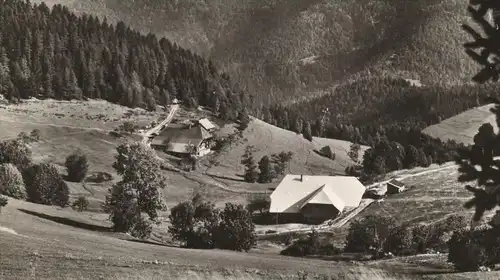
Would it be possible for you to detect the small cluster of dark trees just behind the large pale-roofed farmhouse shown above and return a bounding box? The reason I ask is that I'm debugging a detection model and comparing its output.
[241,145,293,183]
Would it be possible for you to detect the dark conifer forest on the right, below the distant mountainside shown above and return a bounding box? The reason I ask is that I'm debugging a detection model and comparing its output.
[261,78,500,176]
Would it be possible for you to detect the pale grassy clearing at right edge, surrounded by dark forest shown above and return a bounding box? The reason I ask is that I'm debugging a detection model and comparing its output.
[423,104,498,145]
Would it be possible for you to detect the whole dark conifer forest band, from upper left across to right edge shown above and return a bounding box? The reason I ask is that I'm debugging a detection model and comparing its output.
[0,0,484,178]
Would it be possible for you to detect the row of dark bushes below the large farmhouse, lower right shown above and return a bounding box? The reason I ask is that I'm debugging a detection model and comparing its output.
[282,215,467,258]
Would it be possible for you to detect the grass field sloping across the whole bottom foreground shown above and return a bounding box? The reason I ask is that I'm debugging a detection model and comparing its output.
[0,199,499,280]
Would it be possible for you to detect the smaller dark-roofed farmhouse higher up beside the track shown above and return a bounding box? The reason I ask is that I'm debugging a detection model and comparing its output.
[151,124,213,157]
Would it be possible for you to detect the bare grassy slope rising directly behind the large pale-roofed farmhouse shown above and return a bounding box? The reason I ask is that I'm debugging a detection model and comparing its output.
[207,119,368,184]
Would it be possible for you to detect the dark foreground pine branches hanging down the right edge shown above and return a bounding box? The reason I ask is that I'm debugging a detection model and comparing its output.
[456,0,500,226]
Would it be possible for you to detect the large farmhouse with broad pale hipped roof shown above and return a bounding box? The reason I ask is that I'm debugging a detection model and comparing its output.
[269,174,365,223]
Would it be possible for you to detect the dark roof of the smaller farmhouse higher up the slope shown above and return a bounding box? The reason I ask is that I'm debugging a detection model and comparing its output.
[151,124,212,152]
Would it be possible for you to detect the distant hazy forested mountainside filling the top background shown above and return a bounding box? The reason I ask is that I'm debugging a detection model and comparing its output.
[33,0,477,105]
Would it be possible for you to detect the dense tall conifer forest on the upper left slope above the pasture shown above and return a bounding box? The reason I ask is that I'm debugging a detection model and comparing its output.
[0,0,249,119]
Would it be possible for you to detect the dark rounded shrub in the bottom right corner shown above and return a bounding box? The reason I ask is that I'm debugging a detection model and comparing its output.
[448,227,500,271]
